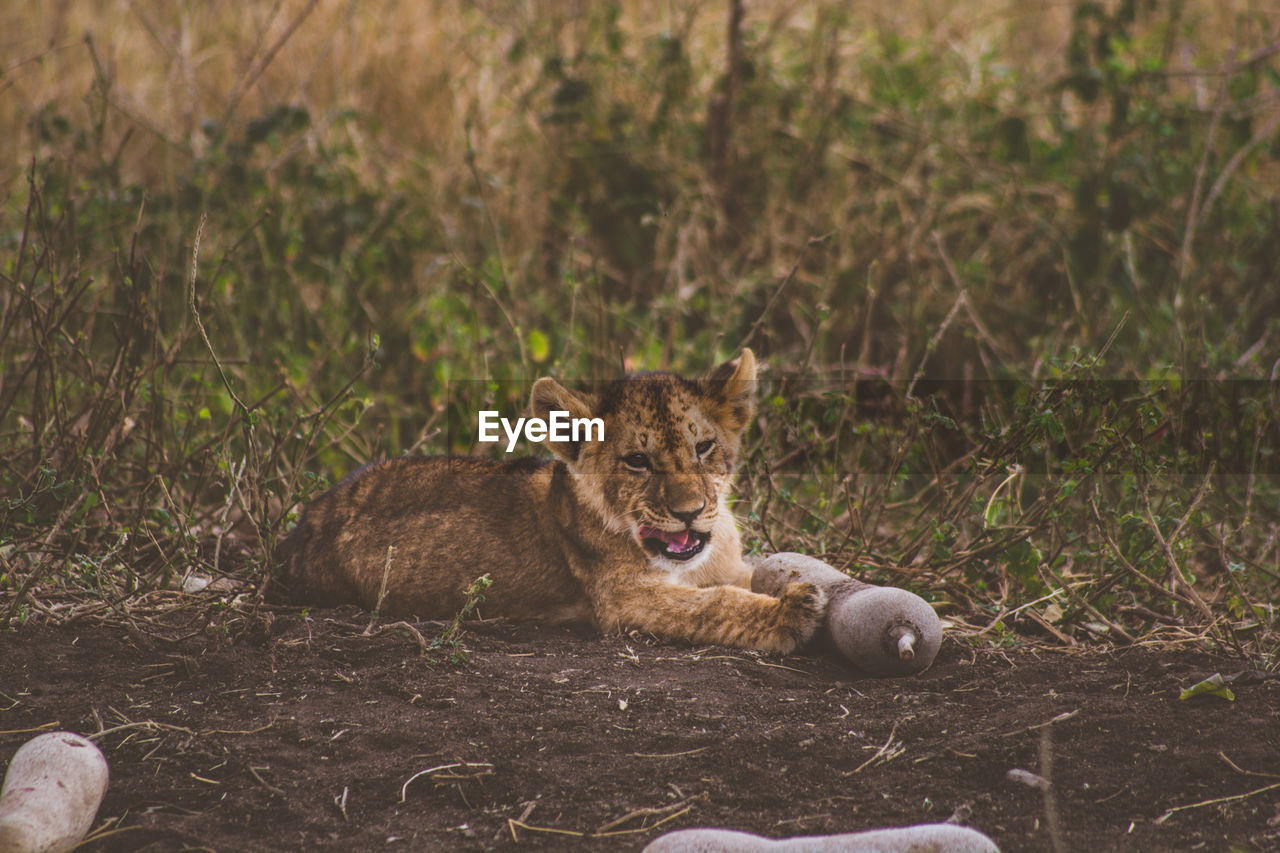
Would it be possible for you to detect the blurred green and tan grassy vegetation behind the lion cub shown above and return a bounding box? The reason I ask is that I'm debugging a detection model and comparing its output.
[0,0,1280,650]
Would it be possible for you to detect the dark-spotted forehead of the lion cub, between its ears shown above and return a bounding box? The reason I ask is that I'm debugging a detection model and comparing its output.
[598,373,716,452]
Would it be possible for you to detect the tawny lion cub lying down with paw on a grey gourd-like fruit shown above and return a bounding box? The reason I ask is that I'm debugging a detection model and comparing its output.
[280,350,826,653]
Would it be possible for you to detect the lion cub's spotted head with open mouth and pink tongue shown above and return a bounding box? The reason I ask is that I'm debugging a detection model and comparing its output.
[531,350,755,570]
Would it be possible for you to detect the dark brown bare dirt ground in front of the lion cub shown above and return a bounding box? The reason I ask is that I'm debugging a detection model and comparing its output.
[0,611,1280,852]
